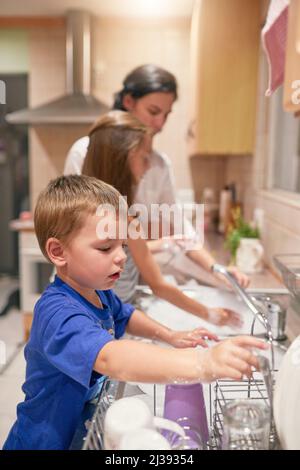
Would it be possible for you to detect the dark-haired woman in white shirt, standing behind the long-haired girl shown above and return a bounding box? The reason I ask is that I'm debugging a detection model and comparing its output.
[64,64,249,287]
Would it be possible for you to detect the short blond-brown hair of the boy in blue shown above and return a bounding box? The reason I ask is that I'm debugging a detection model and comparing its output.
[34,175,121,261]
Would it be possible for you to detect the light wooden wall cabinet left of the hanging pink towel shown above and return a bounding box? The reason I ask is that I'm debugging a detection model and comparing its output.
[190,0,262,156]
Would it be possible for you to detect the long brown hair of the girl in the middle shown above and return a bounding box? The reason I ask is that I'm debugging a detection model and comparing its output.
[82,111,150,205]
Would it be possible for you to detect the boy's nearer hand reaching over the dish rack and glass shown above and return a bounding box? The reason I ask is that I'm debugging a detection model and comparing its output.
[199,336,268,382]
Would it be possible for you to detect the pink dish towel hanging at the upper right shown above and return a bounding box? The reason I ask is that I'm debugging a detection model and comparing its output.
[261,0,289,96]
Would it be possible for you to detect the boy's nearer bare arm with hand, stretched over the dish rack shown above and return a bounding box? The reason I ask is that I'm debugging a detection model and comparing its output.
[94,336,267,383]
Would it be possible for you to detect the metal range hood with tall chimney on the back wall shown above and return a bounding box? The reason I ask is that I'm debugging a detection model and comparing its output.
[6,10,109,125]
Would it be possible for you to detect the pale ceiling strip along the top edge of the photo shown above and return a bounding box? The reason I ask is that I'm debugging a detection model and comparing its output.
[0,0,195,17]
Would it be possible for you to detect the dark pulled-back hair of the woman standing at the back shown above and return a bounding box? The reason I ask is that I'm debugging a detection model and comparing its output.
[113,64,177,111]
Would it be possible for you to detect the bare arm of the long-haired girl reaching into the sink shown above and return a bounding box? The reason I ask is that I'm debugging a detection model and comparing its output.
[128,238,240,326]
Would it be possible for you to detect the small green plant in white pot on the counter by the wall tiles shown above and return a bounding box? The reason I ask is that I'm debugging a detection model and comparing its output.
[225,207,263,273]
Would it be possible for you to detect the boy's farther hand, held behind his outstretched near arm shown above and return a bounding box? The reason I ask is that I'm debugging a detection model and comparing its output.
[168,328,219,348]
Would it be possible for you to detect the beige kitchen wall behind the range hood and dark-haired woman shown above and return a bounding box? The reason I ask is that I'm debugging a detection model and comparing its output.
[29,17,191,205]
